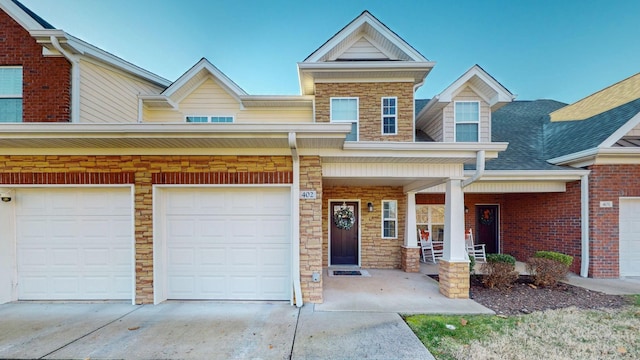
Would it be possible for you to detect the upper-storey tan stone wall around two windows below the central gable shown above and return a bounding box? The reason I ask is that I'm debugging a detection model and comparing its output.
[315,82,414,141]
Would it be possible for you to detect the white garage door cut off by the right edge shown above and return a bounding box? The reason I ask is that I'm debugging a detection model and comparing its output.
[620,198,640,276]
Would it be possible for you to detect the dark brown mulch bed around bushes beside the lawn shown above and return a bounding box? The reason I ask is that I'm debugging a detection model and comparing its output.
[431,275,629,315]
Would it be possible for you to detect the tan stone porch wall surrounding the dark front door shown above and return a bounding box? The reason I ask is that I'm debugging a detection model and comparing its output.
[322,186,407,269]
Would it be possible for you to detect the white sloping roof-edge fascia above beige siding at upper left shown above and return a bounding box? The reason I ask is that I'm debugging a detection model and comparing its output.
[29,29,171,87]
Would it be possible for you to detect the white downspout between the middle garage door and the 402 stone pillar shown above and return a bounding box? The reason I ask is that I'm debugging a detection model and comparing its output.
[289,132,303,307]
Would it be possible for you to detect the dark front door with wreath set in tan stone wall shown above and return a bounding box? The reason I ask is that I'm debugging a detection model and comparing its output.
[329,202,359,265]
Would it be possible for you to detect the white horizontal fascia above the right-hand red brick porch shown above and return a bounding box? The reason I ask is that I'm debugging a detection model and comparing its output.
[476,169,591,182]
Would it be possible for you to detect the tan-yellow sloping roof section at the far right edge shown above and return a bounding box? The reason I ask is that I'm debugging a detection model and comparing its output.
[551,73,640,121]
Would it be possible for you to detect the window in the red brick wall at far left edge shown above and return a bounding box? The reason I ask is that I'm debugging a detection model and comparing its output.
[0,66,22,122]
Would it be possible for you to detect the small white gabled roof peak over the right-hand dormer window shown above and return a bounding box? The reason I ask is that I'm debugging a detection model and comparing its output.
[416,64,515,129]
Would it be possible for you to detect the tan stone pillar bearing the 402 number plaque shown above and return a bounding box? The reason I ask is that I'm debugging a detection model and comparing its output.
[300,156,324,303]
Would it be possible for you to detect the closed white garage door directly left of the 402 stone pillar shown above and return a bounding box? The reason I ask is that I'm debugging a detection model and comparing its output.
[165,188,291,300]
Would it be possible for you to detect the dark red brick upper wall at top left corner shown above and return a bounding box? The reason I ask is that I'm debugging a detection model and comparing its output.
[0,11,71,122]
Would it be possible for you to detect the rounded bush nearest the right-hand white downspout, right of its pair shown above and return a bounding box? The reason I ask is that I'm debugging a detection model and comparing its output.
[527,251,573,286]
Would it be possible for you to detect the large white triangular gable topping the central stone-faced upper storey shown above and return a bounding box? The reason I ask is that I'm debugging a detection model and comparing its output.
[298,11,435,95]
